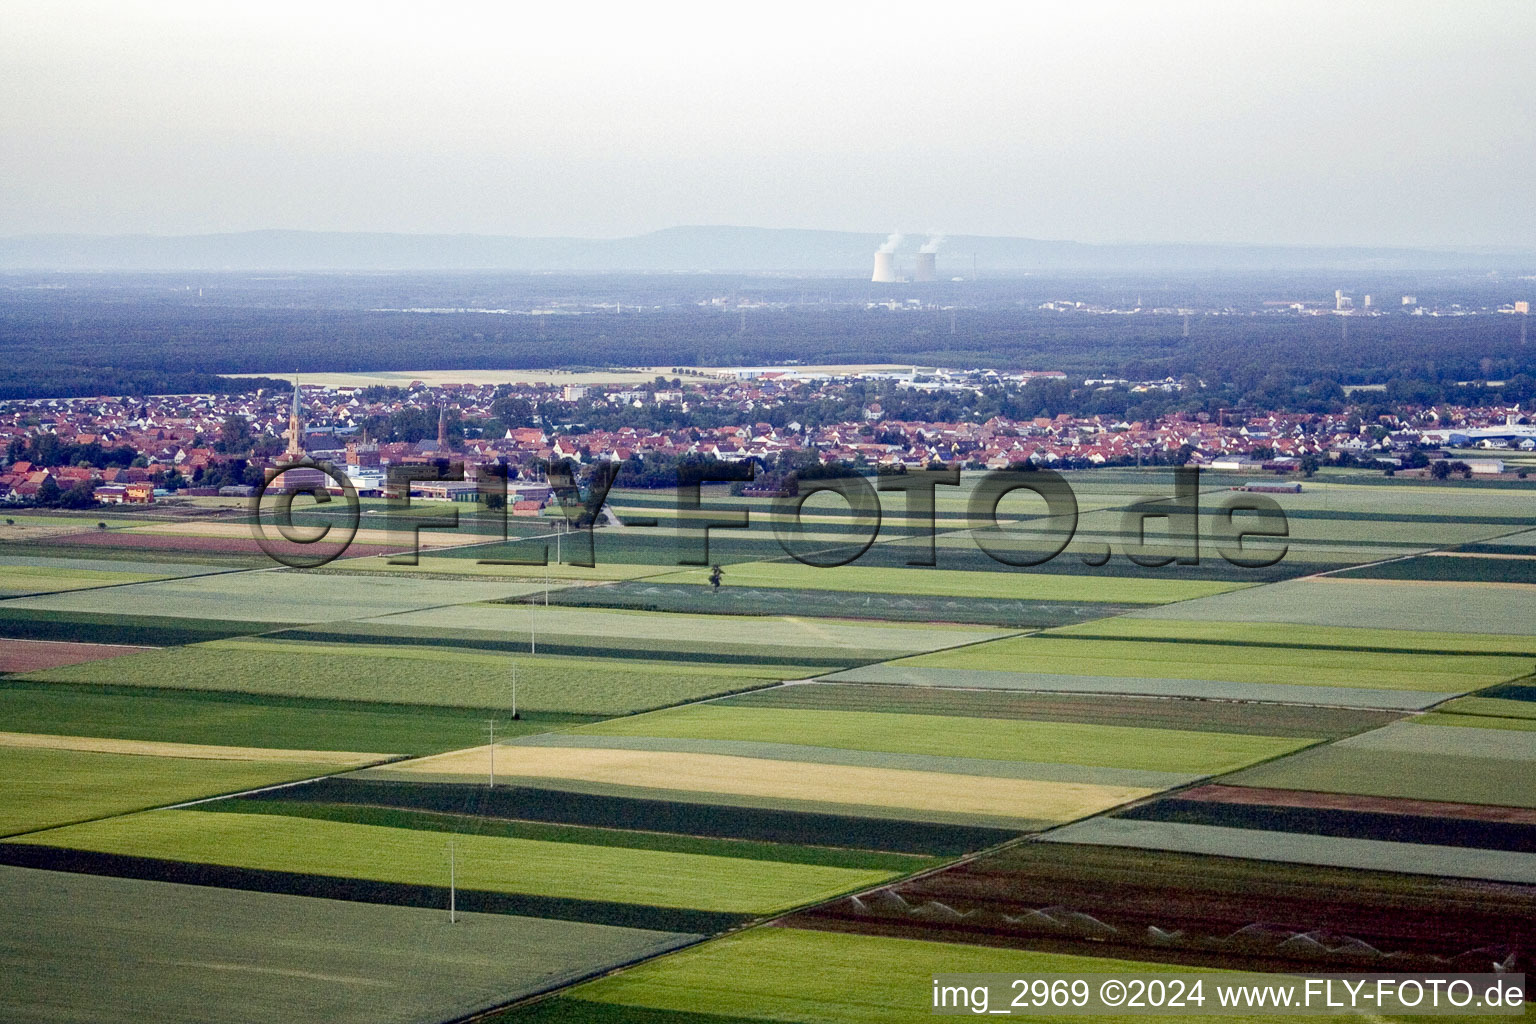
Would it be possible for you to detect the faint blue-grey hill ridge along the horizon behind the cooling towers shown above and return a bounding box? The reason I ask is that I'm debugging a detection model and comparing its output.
[0,227,1536,271]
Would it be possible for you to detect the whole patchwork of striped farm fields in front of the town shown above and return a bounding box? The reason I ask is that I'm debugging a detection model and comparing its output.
[9,471,1536,1024]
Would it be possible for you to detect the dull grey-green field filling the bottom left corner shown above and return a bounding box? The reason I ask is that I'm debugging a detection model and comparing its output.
[0,867,693,1024]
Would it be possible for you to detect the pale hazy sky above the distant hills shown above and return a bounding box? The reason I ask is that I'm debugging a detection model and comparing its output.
[0,0,1536,246]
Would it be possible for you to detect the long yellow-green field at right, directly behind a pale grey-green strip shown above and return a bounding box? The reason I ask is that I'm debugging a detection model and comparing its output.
[897,636,1533,692]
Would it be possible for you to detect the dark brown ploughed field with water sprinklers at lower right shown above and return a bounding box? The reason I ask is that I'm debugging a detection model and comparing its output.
[785,843,1536,972]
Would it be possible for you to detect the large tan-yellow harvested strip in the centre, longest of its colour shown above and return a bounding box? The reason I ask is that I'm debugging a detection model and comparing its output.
[390,745,1155,821]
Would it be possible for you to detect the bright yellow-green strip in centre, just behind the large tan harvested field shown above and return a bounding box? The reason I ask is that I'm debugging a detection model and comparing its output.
[576,705,1306,775]
